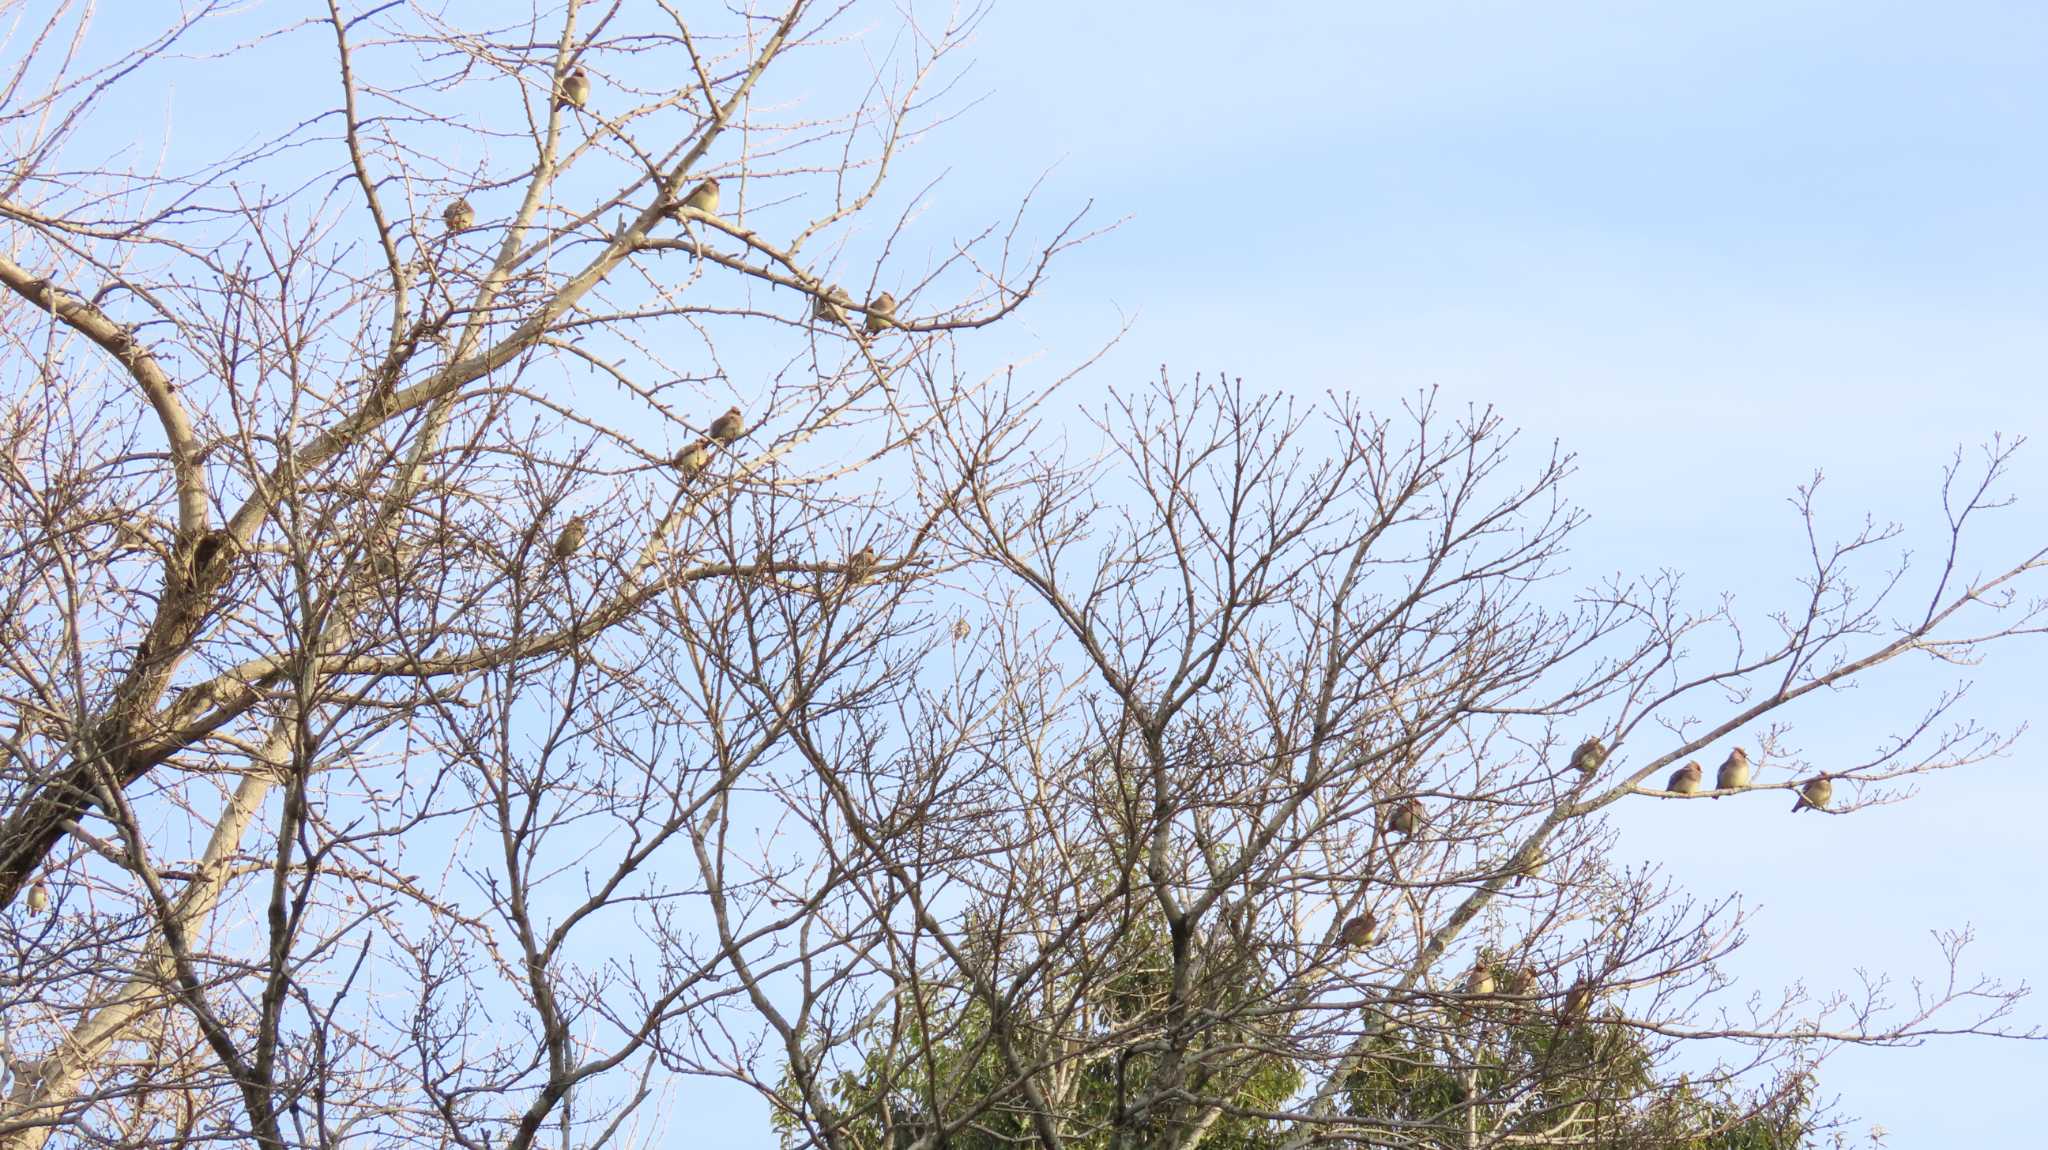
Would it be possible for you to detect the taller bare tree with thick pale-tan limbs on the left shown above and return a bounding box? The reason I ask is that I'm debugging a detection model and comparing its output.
[0,0,1079,1146]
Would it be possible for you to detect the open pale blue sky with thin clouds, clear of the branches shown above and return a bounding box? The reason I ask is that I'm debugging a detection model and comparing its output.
[932,2,2048,1148]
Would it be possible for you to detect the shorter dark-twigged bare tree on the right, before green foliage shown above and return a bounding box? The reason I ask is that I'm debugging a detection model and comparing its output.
[753,379,2048,1148]
